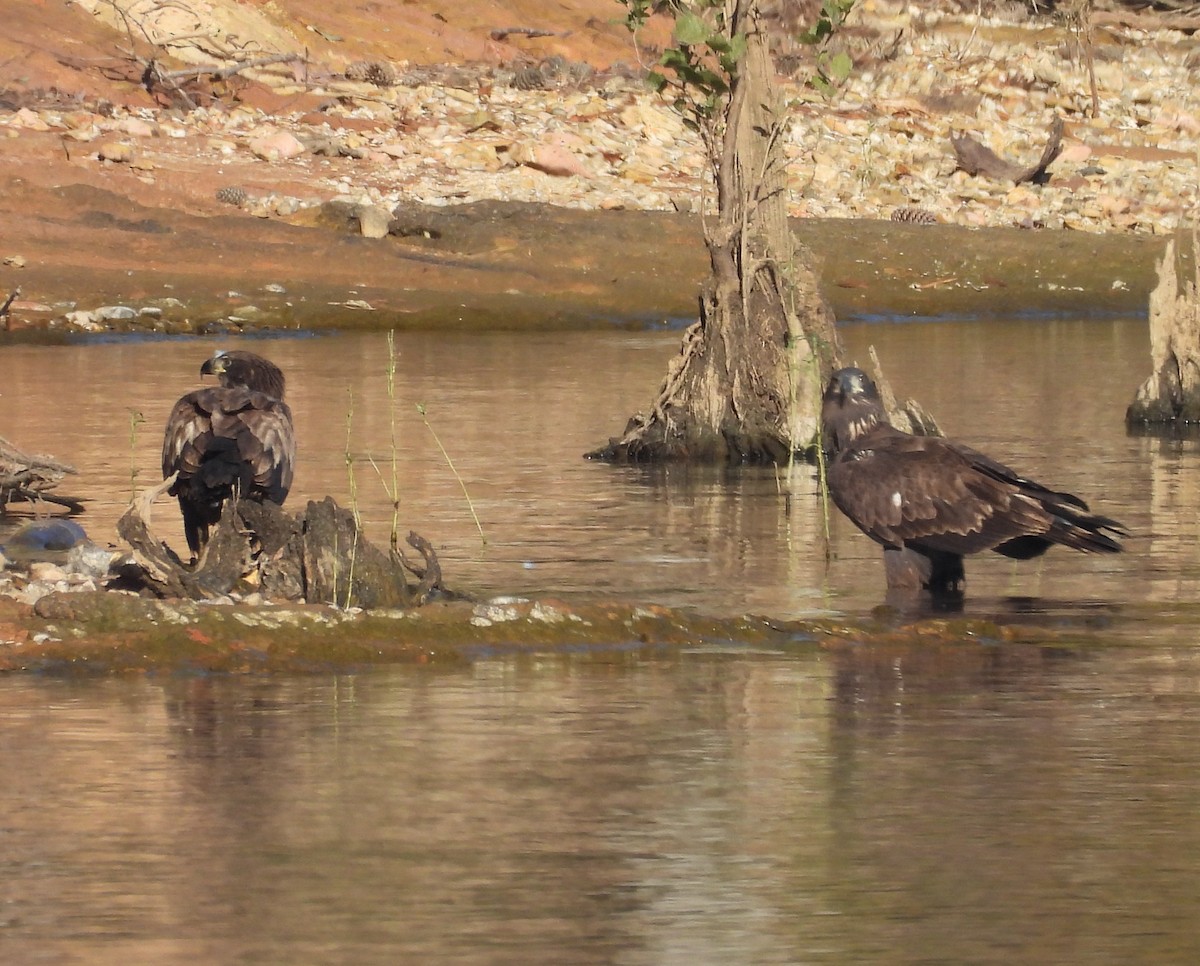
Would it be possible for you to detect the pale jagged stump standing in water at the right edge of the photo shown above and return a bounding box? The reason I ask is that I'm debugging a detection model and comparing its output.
[1126,239,1200,428]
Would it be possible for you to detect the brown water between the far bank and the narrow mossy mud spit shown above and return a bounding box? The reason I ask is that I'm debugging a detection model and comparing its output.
[0,320,1171,617]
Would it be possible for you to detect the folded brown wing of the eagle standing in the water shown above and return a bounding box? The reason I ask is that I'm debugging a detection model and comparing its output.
[828,425,1084,556]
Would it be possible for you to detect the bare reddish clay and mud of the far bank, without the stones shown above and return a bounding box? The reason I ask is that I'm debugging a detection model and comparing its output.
[0,0,1160,326]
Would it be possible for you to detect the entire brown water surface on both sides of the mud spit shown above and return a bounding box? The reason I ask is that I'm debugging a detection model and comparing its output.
[0,320,1200,964]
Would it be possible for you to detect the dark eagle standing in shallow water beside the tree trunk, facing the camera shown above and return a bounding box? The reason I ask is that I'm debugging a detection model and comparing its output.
[821,368,1124,594]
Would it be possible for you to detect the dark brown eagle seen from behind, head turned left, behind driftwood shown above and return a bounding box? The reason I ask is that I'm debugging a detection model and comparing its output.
[162,352,295,554]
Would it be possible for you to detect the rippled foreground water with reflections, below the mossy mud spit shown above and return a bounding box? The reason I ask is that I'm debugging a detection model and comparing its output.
[0,646,1200,964]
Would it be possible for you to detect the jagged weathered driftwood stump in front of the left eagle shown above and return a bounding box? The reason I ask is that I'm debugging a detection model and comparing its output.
[116,479,442,607]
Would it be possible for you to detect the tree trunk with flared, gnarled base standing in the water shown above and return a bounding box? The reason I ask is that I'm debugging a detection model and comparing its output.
[588,0,838,462]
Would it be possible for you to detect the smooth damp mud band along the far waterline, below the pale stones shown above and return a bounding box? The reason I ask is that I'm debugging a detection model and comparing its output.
[5,190,1165,338]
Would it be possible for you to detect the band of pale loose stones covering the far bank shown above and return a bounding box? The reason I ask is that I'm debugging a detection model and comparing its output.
[28,2,1200,234]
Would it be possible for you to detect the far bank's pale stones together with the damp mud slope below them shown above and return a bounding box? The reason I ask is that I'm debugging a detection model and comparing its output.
[0,2,1200,332]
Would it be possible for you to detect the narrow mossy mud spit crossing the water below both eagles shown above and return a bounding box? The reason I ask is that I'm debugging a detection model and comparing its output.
[0,592,1123,676]
